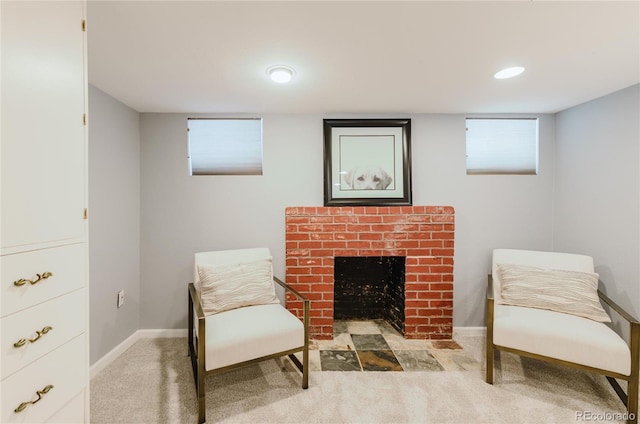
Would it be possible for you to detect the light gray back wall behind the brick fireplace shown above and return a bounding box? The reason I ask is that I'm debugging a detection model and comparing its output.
[140,113,554,329]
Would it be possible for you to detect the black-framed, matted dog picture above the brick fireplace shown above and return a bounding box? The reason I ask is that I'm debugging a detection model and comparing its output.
[324,119,411,206]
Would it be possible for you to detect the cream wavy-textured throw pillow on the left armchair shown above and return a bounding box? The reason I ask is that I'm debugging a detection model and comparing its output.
[198,259,279,315]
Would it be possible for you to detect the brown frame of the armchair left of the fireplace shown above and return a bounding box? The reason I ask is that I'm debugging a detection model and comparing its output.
[188,277,310,424]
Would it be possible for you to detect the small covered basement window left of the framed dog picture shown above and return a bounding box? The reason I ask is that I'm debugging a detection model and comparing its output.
[187,118,262,175]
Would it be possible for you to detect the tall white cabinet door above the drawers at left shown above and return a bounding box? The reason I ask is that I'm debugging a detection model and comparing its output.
[0,0,86,254]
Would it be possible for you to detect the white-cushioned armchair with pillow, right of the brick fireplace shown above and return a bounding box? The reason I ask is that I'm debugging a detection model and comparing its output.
[486,249,640,423]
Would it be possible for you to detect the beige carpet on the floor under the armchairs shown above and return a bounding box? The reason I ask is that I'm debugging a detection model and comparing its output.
[91,337,625,424]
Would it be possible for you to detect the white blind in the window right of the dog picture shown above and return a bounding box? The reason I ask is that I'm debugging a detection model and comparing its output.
[466,118,538,175]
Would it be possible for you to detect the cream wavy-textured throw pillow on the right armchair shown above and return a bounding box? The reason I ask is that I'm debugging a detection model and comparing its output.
[497,264,611,322]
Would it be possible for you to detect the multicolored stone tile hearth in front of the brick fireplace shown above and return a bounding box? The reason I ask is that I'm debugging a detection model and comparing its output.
[309,320,480,371]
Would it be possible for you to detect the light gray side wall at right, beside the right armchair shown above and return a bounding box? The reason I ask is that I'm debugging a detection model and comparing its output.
[553,85,640,317]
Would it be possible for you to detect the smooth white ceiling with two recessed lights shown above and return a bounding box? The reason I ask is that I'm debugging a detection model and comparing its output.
[88,0,640,114]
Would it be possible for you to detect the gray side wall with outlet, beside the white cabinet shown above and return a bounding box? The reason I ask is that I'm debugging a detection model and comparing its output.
[89,85,140,364]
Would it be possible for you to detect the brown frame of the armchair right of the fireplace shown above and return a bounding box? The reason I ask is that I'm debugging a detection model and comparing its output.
[486,274,640,424]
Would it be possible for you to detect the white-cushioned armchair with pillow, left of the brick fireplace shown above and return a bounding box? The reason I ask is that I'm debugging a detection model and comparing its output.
[188,248,309,423]
